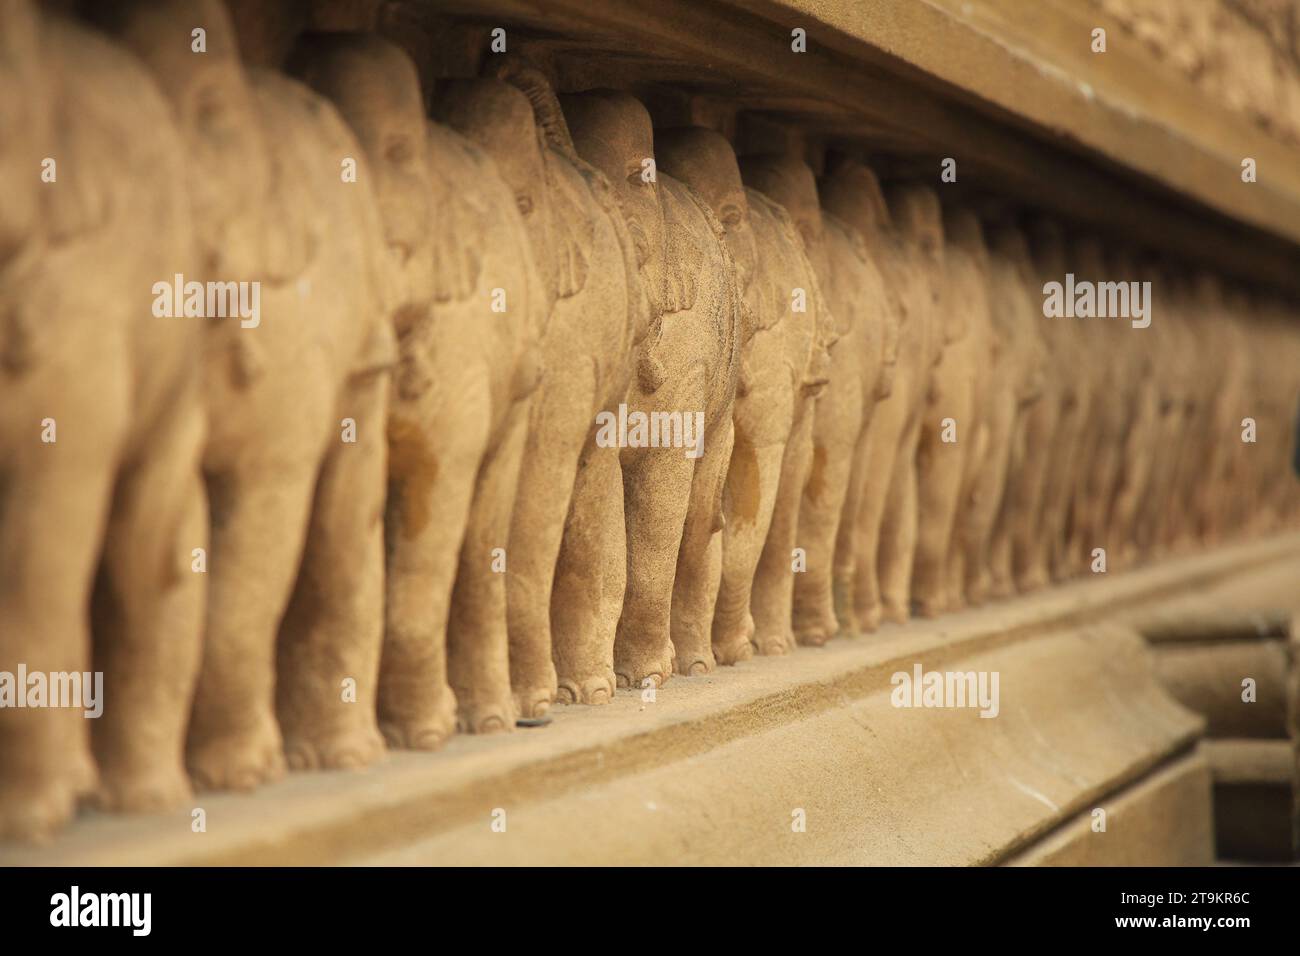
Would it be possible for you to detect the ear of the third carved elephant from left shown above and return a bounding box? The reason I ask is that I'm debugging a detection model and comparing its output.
[428,124,497,302]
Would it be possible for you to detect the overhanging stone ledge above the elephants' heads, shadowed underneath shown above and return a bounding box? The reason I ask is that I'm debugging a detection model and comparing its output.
[410,0,1300,290]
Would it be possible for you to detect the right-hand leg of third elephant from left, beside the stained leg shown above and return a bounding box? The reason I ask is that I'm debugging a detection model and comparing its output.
[447,401,530,734]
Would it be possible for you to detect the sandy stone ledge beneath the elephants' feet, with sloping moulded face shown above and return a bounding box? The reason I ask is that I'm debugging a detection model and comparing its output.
[0,535,1300,865]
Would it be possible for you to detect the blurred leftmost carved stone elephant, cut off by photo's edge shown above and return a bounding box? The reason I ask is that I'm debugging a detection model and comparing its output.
[0,0,207,840]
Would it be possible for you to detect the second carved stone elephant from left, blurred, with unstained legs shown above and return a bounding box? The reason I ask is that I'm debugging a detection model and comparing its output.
[92,0,395,788]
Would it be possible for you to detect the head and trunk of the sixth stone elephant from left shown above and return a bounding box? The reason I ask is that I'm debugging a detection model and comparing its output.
[655,126,759,345]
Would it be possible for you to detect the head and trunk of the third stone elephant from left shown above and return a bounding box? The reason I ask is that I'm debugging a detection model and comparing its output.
[289,33,434,336]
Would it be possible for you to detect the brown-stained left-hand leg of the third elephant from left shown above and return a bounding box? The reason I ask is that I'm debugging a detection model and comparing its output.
[378,398,489,750]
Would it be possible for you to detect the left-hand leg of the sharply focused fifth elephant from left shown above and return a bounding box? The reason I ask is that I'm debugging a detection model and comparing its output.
[614,449,696,687]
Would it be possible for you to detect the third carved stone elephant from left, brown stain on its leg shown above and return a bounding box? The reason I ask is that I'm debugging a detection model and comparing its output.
[293,35,554,749]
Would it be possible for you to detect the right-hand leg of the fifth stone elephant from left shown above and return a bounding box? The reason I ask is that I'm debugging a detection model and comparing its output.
[672,410,736,678]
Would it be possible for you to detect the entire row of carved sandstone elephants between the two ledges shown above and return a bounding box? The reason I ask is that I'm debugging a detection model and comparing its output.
[0,0,1300,838]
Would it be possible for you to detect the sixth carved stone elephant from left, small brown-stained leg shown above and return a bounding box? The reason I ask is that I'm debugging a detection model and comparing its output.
[655,127,833,663]
